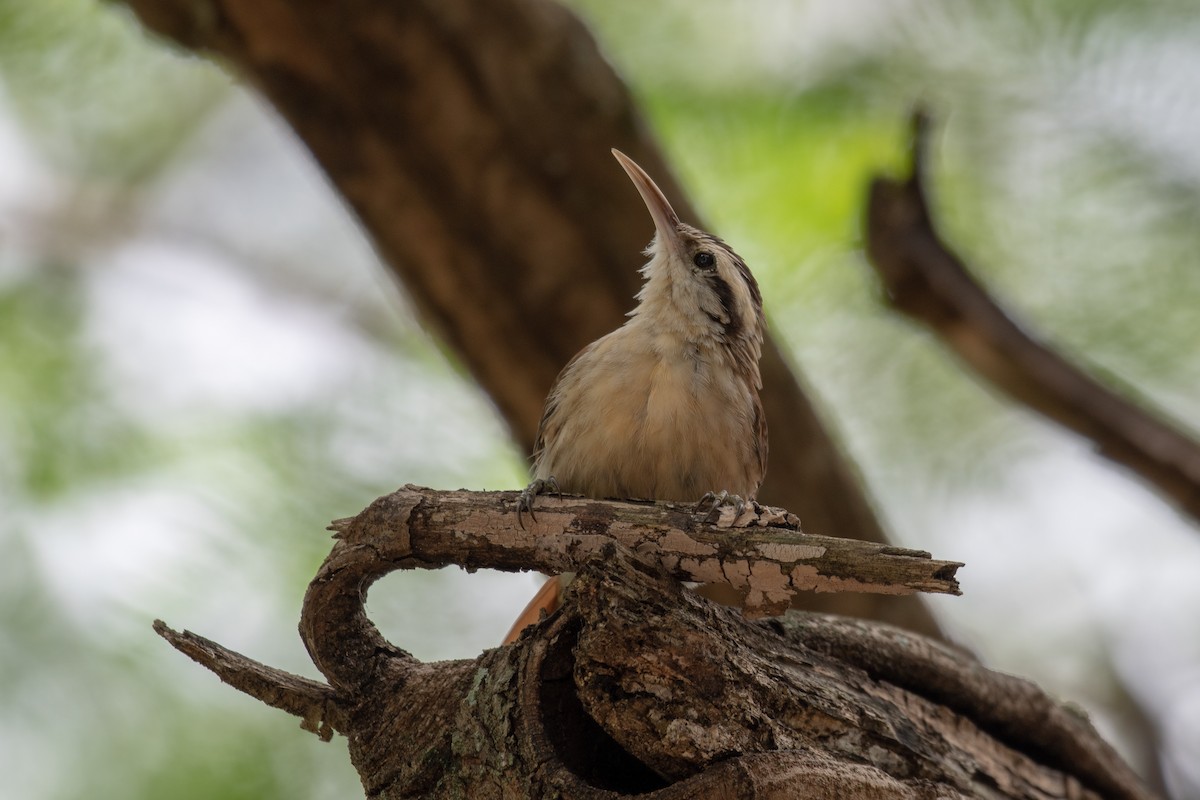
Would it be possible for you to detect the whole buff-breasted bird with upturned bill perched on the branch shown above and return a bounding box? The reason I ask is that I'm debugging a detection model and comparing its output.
[505,149,767,642]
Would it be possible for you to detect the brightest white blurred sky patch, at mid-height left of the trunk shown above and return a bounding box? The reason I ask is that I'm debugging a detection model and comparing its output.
[81,242,370,420]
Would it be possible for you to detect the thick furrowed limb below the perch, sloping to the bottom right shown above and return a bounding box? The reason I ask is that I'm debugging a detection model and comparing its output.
[575,554,1145,798]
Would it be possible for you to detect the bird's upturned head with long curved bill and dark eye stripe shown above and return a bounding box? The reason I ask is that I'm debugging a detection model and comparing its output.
[612,150,763,363]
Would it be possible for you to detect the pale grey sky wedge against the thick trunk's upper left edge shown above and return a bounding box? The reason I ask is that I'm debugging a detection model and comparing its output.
[142,91,418,330]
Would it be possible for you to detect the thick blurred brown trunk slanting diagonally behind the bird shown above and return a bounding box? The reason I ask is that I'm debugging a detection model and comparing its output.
[117,0,937,634]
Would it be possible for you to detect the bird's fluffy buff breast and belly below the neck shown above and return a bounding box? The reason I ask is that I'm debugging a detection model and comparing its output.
[535,329,762,501]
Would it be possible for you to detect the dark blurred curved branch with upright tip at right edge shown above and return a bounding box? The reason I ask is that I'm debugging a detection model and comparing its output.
[866,115,1200,521]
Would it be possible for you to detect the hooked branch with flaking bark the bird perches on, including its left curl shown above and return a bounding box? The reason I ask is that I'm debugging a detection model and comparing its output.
[300,486,962,686]
